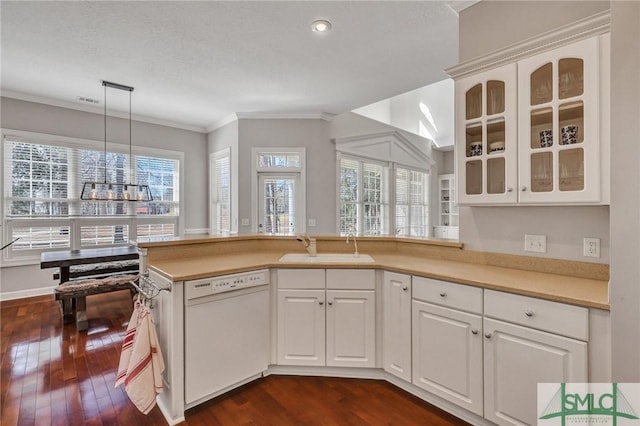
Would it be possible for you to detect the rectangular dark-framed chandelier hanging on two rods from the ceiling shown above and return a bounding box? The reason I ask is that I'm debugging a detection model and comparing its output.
[80,80,153,202]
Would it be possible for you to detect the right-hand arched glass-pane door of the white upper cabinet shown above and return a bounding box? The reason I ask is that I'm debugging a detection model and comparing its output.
[518,37,600,203]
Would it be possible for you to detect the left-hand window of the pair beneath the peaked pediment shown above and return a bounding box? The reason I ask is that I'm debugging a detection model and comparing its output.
[339,158,388,235]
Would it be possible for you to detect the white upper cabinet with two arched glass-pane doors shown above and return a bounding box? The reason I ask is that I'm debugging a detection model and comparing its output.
[455,34,610,205]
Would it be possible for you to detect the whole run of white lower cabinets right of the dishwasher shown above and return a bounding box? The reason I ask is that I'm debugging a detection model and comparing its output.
[277,269,596,426]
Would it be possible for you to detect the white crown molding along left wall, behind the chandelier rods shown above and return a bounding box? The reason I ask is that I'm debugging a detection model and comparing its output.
[0,89,207,133]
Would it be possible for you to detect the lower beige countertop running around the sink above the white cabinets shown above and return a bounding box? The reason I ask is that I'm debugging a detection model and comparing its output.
[149,251,609,310]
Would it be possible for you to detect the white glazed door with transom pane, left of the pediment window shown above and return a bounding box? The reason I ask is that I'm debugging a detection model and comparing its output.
[253,148,305,235]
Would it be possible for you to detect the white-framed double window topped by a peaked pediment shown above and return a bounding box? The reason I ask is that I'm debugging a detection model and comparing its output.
[334,131,435,237]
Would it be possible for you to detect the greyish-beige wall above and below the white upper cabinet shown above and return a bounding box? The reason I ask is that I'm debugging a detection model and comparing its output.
[459,1,609,263]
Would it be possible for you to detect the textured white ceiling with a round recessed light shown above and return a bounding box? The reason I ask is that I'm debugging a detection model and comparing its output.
[0,1,458,131]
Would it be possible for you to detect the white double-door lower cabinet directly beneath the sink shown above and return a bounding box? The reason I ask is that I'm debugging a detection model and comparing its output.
[277,269,376,367]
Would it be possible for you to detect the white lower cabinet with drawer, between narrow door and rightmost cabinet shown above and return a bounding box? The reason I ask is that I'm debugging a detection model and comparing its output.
[412,277,482,416]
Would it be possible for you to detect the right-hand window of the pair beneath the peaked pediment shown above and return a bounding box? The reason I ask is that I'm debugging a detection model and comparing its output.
[396,167,429,237]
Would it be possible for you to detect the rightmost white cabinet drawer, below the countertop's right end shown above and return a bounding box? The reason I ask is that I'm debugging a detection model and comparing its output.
[484,290,589,341]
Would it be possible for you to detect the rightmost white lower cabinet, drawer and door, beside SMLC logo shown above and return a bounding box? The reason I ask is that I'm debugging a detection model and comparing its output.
[484,290,588,425]
